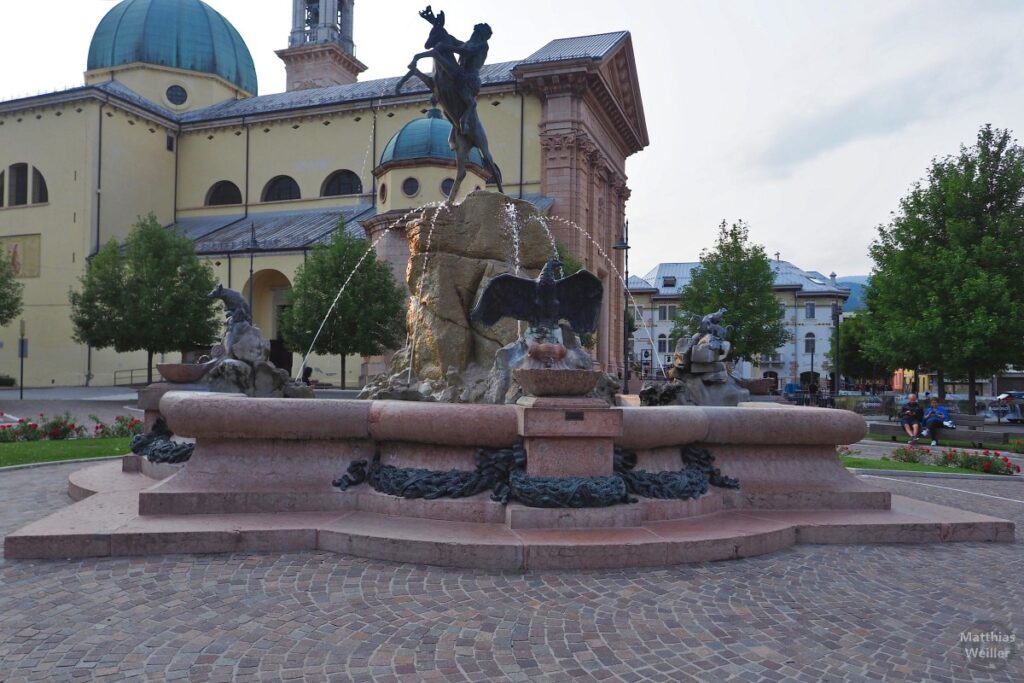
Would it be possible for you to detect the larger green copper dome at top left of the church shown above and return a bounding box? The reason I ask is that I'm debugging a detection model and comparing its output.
[88,0,257,95]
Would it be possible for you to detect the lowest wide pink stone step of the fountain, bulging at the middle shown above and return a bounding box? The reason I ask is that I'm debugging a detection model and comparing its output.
[4,490,1014,570]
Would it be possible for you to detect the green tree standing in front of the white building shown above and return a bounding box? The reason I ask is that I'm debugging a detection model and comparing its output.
[672,220,790,358]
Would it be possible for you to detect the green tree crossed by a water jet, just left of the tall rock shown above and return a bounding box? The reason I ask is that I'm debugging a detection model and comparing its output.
[281,221,406,388]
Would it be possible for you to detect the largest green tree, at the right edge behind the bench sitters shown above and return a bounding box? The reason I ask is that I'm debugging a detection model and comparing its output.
[866,125,1024,412]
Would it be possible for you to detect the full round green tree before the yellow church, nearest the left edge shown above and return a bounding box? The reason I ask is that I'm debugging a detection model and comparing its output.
[70,213,219,383]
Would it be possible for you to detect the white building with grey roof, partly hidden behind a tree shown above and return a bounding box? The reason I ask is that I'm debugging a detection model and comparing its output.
[629,260,850,390]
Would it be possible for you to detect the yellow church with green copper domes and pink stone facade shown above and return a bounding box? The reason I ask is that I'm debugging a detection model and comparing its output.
[0,0,649,386]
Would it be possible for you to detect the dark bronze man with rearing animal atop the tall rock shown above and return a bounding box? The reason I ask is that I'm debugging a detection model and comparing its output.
[395,5,505,202]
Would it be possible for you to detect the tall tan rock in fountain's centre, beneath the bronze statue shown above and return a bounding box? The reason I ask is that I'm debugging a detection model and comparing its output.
[360,191,617,403]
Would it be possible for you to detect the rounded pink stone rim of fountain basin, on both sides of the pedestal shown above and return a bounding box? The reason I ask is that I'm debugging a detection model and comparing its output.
[160,391,866,450]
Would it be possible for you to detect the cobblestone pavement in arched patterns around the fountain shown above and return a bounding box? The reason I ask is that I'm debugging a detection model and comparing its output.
[0,465,1024,683]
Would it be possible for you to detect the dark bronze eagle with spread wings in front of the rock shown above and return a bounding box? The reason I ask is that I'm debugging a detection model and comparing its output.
[470,258,604,333]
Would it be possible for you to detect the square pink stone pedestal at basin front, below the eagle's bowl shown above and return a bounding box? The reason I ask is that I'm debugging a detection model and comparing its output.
[516,396,623,477]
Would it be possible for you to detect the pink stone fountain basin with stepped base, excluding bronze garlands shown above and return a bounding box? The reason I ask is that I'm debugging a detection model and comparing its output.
[4,391,1014,570]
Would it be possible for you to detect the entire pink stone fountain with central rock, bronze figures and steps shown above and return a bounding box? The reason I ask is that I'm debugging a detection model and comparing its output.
[4,7,1015,570]
